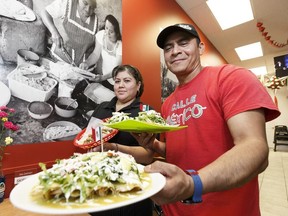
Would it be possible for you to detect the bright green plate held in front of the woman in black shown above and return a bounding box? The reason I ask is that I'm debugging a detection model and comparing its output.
[103,119,188,133]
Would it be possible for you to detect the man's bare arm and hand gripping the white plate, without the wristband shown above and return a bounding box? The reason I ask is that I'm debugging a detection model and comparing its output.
[145,109,269,205]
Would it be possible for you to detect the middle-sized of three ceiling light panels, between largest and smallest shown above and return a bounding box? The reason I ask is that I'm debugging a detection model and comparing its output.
[235,42,263,61]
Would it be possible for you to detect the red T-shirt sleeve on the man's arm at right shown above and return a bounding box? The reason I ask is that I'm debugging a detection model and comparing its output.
[219,65,280,121]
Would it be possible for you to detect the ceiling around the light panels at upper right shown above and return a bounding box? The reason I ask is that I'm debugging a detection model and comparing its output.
[175,0,288,74]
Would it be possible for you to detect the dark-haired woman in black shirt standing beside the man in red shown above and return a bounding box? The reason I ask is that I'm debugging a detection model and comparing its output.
[91,65,153,216]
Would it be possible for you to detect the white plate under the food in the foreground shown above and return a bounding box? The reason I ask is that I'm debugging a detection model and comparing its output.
[10,170,166,215]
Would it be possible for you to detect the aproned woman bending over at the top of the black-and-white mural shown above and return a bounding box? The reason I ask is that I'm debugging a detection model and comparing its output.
[41,0,98,66]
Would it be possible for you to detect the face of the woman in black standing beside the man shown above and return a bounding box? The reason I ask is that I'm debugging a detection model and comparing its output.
[114,71,141,103]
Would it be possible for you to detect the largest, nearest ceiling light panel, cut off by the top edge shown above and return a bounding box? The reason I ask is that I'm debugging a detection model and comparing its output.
[206,0,254,30]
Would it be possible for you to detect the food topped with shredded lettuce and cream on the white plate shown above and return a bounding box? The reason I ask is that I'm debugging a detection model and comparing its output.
[35,151,144,203]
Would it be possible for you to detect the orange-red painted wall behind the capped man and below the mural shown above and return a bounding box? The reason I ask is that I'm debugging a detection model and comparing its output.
[3,0,226,197]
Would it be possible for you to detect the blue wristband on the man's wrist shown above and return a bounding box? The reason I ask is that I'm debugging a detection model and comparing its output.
[181,170,203,204]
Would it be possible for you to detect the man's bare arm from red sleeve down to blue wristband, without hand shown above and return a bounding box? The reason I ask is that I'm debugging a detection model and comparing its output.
[199,110,269,193]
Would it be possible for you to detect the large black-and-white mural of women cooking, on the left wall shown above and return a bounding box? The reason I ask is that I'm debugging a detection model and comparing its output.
[0,0,122,144]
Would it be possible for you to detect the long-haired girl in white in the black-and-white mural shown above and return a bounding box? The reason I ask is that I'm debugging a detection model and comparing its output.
[79,14,122,104]
